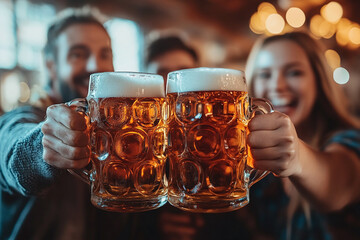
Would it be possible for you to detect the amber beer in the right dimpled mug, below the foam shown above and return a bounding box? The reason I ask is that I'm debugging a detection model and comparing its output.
[167,91,250,212]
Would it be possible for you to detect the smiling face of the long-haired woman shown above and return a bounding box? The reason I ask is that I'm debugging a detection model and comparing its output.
[250,40,317,126]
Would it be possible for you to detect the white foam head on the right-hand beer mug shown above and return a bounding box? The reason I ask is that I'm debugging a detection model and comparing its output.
[167,67,247,93]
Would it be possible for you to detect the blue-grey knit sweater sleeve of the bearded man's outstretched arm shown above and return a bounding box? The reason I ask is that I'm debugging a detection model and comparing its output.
[0,106,64,196]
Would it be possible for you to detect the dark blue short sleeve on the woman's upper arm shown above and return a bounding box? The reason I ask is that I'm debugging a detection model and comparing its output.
[327,129,360,157]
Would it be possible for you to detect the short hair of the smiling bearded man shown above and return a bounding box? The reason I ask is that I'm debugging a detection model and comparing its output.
[44,7,107,60]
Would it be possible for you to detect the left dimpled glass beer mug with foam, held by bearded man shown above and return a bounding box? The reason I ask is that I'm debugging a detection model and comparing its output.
[70,72,167,212]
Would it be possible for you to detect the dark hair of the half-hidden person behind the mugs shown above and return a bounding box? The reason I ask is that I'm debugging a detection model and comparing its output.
[145,36,198,65]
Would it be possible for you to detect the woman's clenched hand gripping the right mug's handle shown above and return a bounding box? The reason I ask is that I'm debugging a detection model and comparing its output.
[247,111,301,177]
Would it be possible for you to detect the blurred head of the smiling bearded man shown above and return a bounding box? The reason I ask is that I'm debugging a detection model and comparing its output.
[45,7,113,103]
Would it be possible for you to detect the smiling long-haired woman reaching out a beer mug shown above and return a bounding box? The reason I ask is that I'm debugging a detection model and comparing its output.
[246,32,360,239]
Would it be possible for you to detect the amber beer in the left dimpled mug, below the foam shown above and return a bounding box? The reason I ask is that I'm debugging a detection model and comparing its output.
[89,97,167,212]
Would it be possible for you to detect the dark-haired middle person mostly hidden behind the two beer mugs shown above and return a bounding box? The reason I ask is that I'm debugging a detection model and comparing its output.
[145,34,251,240]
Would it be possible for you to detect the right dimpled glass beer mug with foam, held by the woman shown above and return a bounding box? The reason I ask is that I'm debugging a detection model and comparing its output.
[166,68,272,212]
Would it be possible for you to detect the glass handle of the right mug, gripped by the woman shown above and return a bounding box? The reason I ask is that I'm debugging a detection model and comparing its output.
[246,97,274,187]
